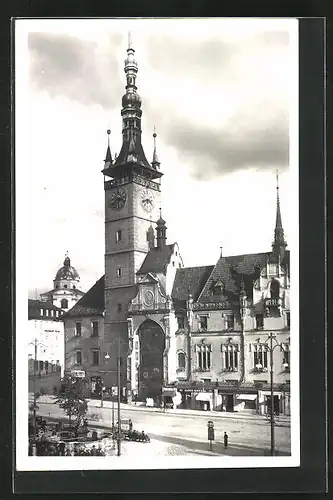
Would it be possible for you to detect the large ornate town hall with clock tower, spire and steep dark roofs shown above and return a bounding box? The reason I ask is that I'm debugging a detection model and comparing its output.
[63,37,290,414]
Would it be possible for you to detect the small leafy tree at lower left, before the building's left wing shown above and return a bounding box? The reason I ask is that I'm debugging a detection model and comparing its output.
[55,376,89,430]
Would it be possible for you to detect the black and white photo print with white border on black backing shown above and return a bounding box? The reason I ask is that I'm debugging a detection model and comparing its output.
[14,18,300,471]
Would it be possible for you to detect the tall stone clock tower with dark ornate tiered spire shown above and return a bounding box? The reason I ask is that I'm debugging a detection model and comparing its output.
[101,38,162,376]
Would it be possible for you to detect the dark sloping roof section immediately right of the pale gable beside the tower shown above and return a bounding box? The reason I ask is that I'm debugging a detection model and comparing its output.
[171,266,214,305]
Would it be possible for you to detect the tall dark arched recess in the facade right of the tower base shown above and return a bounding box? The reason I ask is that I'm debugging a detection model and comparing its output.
[138,320,165,399]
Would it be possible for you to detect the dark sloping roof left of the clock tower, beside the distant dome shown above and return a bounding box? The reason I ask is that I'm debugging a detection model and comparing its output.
[62,276,105,318]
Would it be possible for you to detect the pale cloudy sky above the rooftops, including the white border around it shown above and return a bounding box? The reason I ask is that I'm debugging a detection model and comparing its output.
[16,18,298,296]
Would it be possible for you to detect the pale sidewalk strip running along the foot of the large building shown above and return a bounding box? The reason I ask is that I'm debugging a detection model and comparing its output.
[29,394,290,425]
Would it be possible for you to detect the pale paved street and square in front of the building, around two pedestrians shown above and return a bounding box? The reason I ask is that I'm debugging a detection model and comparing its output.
[28,397,290,459]
